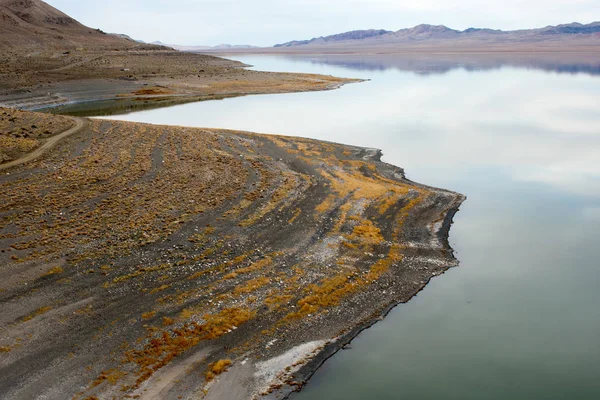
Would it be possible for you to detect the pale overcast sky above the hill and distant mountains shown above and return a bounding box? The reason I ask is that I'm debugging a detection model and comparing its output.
[46,0,600,46]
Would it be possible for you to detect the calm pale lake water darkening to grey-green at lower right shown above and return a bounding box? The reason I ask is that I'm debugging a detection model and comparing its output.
[103,57,600,400]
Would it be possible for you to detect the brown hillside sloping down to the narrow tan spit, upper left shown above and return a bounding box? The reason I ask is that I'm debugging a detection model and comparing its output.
[0,0,352,110]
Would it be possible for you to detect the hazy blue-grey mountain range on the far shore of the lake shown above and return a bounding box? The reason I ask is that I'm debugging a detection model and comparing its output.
[274,22,600,51]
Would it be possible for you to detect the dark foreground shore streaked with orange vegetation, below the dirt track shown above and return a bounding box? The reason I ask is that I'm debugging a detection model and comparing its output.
[0,107,464,399]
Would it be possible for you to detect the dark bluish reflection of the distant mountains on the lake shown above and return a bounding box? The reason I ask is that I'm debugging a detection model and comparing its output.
[278,53,600,75]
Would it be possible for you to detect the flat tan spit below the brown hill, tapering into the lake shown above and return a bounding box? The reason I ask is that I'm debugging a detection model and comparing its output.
[0,51,359,110]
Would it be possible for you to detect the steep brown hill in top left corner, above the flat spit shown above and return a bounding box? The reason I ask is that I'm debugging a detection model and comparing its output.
[0,0,145,50]
